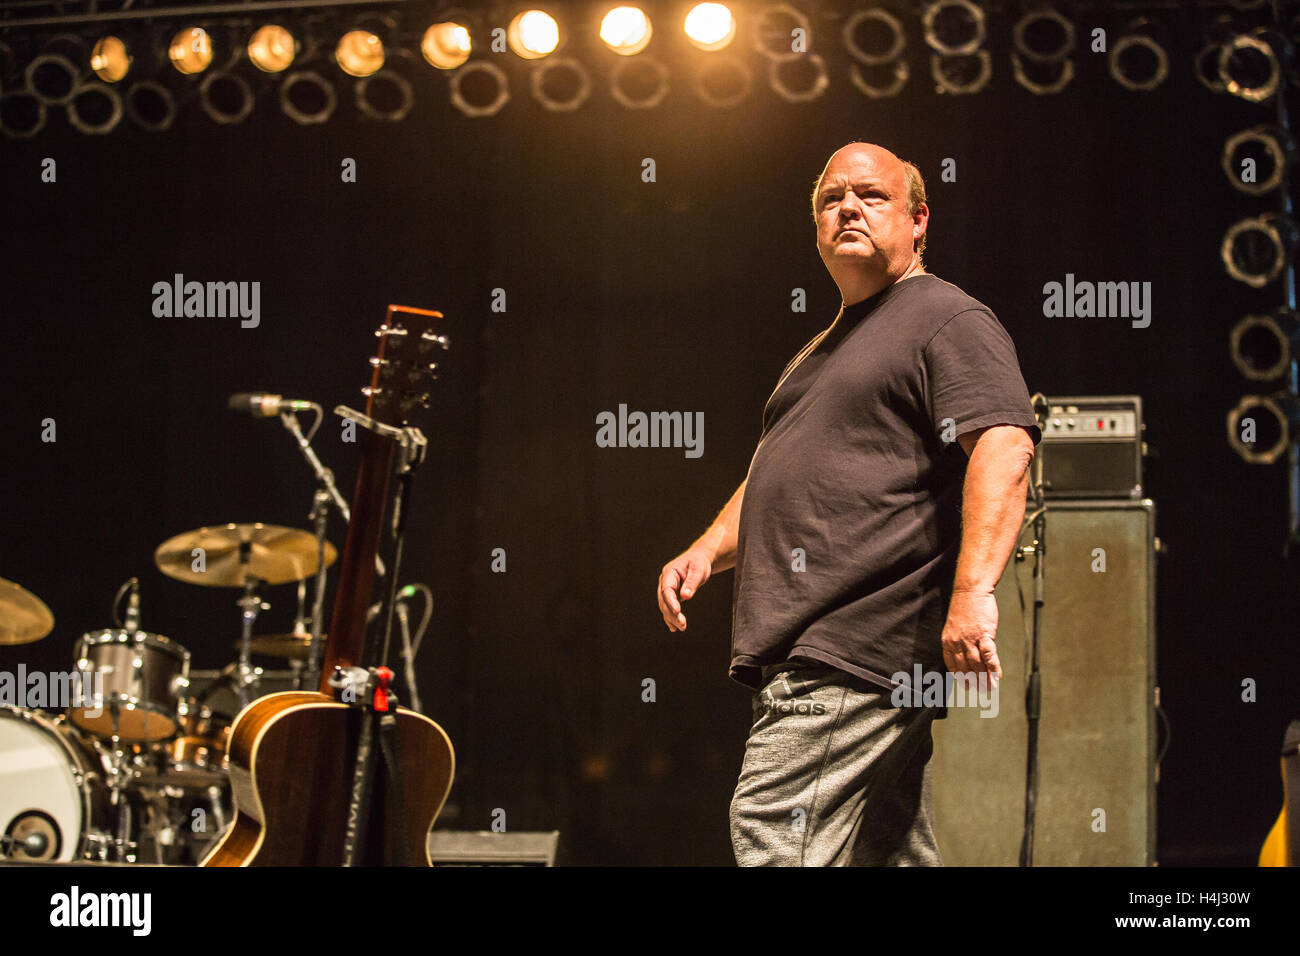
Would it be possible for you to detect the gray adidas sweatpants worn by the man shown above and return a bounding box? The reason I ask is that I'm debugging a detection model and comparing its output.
[731,658,943,866]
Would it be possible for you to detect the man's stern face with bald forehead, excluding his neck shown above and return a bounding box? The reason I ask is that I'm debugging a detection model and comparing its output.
[816,143,926,278]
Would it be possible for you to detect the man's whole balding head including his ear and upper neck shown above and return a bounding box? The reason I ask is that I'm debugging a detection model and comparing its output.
[813,143,930,304]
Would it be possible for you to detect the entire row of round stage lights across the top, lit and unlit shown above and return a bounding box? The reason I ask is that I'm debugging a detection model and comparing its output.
[0,0,1206,138]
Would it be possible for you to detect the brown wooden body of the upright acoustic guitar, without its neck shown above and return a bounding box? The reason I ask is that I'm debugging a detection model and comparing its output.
[200,691,456,866]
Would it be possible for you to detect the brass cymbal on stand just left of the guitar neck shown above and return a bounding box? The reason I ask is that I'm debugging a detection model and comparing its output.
[153,522,338,588]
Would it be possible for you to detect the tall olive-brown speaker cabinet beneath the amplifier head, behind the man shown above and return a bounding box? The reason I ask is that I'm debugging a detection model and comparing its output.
[932,499,1158,866]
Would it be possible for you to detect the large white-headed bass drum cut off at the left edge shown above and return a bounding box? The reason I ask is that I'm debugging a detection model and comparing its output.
[0,705,109,862]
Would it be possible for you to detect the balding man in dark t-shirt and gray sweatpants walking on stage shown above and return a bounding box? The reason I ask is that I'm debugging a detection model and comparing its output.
[658,143,1041,865]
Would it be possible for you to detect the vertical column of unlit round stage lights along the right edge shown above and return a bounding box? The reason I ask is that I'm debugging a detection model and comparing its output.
[1197,22,1300,464]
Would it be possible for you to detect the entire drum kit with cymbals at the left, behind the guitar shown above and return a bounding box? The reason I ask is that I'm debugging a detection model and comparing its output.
[0,522,337,864]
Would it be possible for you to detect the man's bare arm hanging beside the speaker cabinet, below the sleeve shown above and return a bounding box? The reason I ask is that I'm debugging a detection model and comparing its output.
[943,425,1034,679]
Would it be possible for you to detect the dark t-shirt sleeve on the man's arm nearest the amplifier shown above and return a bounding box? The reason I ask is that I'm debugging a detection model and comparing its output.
[924,308,1043,445]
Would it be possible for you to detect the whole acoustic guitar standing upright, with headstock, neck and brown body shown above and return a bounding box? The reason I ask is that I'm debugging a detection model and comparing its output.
[200,306,455,866]
